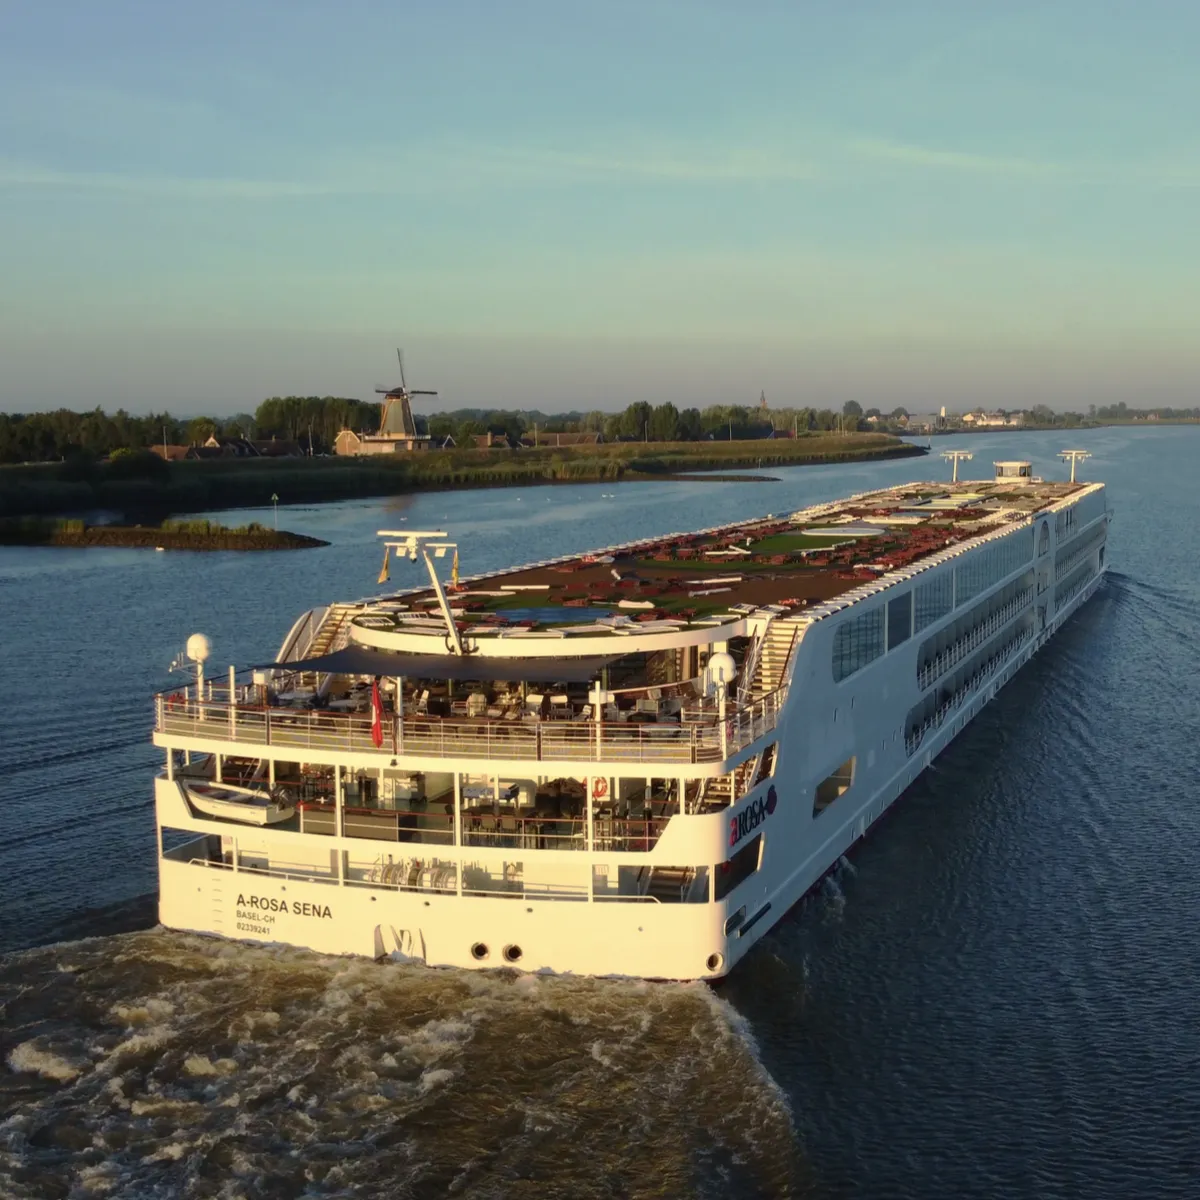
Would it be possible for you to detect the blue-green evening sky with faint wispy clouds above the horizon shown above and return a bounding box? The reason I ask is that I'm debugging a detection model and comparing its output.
[0,0,1200,414]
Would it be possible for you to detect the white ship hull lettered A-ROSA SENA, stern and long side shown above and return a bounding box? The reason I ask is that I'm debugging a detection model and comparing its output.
[155,488,1108,980]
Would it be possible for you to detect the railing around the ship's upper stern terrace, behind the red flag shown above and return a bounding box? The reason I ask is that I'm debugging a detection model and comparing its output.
[155,688,786,763]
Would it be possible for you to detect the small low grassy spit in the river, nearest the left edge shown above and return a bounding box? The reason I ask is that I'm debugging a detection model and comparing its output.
[0,517,329,551]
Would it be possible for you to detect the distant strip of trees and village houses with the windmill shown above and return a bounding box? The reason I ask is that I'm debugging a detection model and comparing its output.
[0,385,1200,464]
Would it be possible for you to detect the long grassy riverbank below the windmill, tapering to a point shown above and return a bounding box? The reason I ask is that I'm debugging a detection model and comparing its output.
[0,433,925,528]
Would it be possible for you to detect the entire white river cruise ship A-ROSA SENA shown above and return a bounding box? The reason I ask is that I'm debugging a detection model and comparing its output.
[154,453,1109,979]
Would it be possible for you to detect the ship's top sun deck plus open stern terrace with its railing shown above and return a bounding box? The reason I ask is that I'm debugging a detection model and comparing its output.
[156,478,1086,773]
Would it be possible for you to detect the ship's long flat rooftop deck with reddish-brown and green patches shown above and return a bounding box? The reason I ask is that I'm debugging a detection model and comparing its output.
[350,478,1085,654]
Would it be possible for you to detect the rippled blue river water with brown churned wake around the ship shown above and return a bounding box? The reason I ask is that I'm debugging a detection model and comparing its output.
[0,427,1200,1198]
